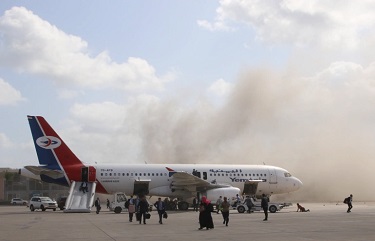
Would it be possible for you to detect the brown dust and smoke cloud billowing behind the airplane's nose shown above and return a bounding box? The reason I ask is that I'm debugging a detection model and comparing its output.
[133,66,375,202]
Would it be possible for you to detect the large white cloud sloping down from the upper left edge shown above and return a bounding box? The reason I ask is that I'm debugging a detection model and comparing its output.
[0,7,172,90]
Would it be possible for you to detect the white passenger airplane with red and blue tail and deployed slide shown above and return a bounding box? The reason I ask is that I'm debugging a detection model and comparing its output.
[21,116,302,212]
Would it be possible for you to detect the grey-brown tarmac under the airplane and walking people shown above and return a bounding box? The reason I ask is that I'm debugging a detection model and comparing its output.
[0,202,375,241]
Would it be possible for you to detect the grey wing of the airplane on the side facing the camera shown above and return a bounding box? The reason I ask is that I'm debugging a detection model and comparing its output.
[171,172,230,191]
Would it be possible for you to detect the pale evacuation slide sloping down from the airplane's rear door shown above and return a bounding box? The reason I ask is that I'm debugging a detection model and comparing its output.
[64,181,96,213]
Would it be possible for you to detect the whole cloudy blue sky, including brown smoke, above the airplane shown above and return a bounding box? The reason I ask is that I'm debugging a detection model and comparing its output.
[0,0,375,198]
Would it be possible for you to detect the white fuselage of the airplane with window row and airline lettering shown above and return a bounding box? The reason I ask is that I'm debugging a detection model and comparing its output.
[95,164,302,196]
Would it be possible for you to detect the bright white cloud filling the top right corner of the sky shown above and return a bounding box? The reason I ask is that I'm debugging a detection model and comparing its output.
[200,0,375,49]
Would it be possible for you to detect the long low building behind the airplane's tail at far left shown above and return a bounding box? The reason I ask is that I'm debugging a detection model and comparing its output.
[0,168,69,201]
